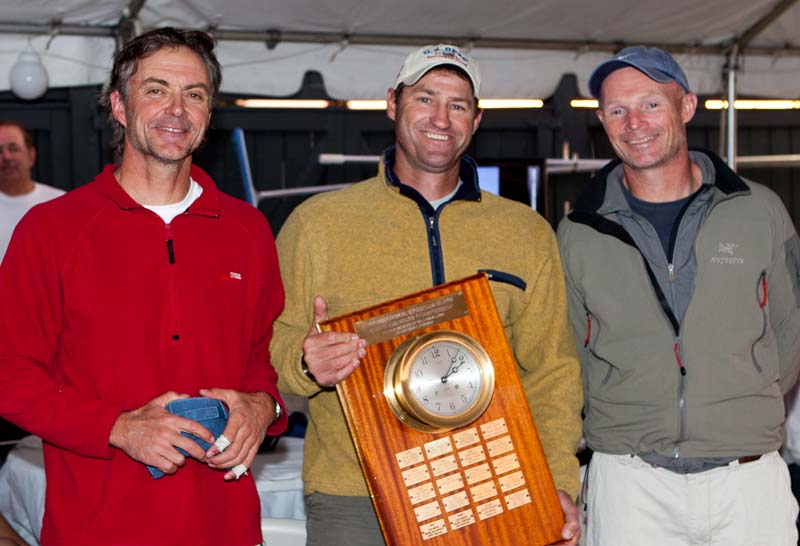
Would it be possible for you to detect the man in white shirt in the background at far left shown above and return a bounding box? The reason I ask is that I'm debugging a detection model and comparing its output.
[0,120,64,262]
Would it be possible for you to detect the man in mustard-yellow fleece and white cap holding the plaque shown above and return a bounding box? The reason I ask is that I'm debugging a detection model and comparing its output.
[271,45,582,546]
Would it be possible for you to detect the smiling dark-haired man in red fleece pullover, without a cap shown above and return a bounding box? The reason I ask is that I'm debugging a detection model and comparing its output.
[0,28,286,546]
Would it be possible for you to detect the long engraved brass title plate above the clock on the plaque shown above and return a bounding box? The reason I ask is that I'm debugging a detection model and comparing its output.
[353,290,468,345]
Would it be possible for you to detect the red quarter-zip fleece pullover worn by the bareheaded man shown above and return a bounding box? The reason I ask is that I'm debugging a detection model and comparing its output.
[0,166,286,546]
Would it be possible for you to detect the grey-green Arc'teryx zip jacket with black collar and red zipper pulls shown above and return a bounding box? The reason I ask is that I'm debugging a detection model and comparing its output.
[558,151,800,472]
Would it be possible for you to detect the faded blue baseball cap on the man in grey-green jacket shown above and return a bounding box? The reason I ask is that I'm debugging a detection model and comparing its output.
[589,46,691,98]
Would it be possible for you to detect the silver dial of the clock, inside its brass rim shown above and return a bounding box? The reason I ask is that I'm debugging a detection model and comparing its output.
[409,340,482,417]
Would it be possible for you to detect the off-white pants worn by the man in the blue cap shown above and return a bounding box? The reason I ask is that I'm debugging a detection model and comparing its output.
[581,452,798,546]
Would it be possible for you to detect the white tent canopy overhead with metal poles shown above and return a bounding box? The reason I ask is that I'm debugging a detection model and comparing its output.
[0,0,800,99]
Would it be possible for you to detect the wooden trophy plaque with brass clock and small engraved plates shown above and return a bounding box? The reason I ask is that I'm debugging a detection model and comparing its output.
[319,274,564,546]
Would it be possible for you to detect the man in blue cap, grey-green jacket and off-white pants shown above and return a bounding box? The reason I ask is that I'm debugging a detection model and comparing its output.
[558,47,800,546]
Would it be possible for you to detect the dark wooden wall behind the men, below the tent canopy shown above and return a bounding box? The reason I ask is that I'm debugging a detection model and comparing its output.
[0,76,800,232]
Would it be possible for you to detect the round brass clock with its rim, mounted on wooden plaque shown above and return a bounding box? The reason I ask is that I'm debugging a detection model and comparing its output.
[383,330,494,432]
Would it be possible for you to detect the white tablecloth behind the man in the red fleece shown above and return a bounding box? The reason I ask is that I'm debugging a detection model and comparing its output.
[0,436,305,544]
